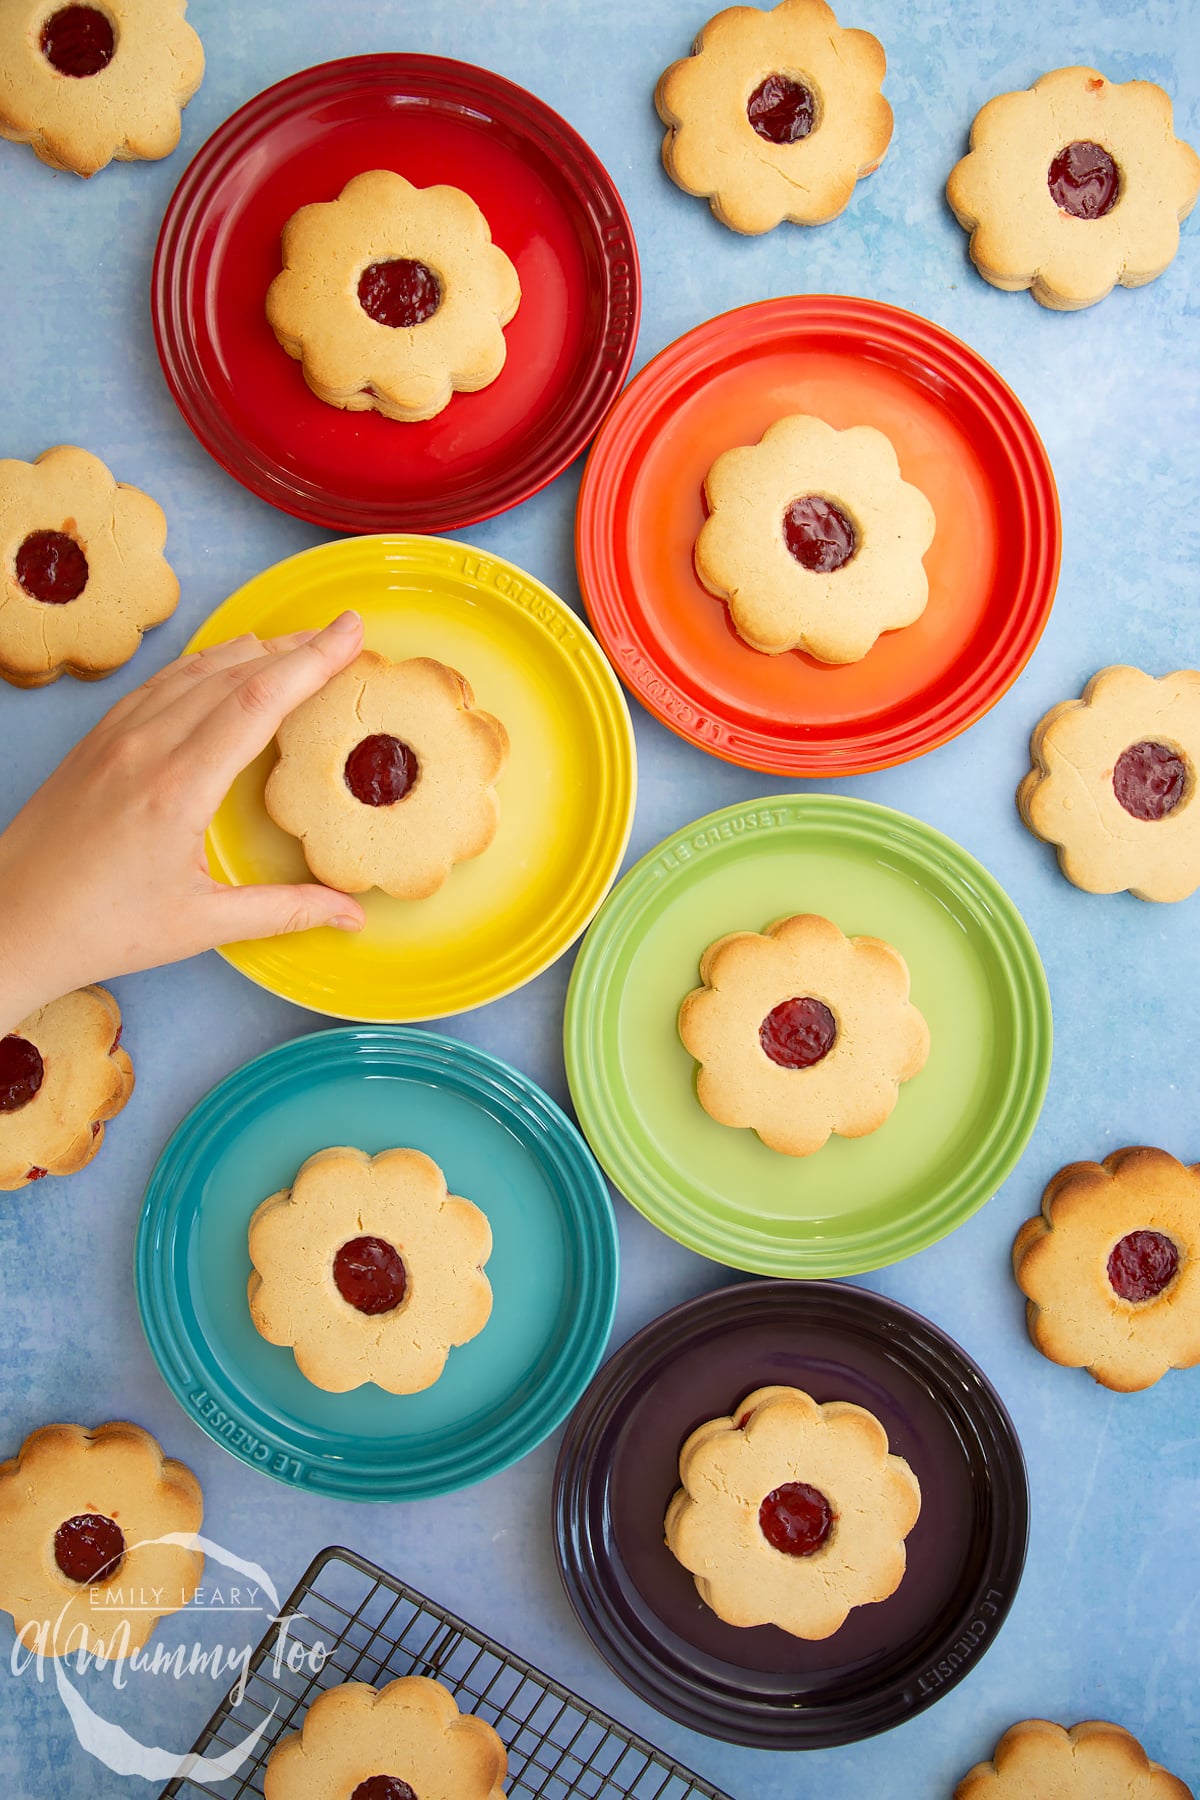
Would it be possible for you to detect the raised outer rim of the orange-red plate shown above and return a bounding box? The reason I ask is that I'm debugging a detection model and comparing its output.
[576,293,1061,779]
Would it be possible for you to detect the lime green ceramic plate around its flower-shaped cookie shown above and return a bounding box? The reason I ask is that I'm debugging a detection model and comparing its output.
[565,794,1052,1276]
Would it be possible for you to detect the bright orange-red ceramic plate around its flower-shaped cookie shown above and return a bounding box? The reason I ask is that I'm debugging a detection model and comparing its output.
[576,293,1060,776]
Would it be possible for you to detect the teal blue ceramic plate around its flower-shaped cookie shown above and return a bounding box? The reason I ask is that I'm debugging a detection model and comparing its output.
[135,1026,617,1501]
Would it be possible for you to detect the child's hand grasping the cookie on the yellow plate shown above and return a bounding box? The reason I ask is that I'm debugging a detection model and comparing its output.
[0,612,363,1035]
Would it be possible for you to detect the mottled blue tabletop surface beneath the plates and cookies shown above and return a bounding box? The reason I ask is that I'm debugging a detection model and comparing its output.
[0,0,1200,1800]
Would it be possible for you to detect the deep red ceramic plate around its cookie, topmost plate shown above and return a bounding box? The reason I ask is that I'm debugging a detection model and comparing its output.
[151,56,640,533]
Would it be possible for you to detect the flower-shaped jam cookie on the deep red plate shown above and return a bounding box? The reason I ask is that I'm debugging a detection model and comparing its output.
[266,169,520,419]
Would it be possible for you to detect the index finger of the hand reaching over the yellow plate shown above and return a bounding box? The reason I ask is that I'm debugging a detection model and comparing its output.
[182,612,362,808]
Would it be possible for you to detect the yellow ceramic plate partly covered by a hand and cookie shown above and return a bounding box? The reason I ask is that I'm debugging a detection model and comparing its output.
[187,536,637,1024]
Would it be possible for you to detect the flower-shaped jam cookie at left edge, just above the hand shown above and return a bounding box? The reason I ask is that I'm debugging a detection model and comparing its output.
[0,445,180,688]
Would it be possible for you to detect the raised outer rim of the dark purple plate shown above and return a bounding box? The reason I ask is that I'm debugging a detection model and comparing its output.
[551,1278,1031,1751]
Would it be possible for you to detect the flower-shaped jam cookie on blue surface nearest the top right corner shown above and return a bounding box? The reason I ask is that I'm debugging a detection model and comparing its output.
[946,68,1200,311]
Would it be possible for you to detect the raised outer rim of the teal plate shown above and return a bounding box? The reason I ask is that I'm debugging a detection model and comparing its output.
[133,1024,621,1503]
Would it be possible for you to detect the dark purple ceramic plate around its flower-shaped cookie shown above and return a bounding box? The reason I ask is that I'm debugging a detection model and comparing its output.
[554,1282,1029,1750]
